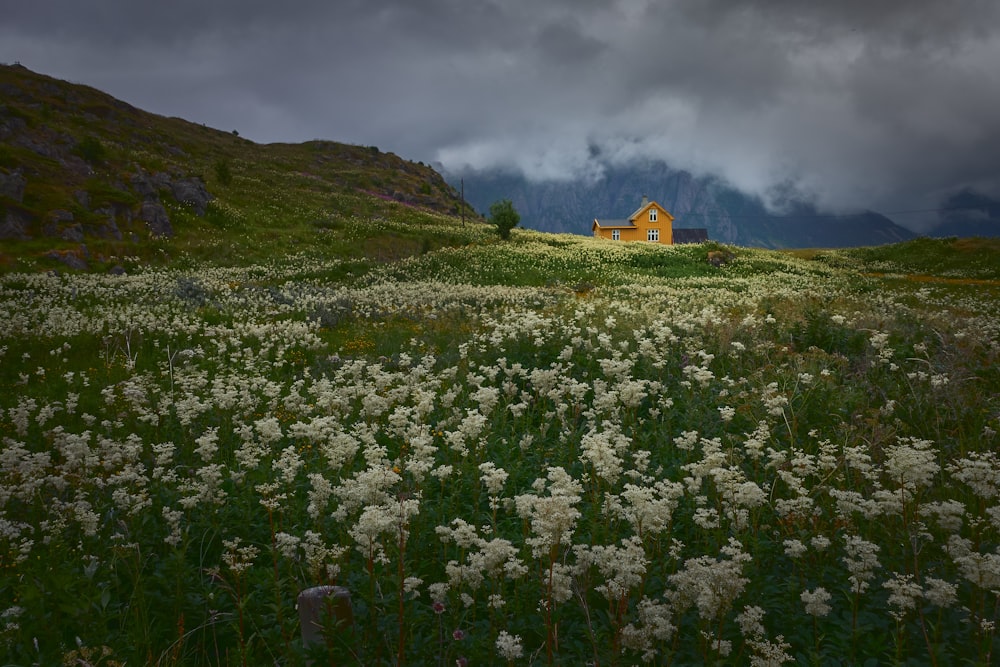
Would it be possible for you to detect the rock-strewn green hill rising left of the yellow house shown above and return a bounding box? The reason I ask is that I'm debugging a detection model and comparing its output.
[0,65,472,268]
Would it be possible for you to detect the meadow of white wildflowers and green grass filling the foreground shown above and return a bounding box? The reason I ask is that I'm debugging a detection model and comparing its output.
[0,236,1000,666]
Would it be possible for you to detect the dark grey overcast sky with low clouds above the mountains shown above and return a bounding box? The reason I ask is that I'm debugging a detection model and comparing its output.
[0,0,1000,224]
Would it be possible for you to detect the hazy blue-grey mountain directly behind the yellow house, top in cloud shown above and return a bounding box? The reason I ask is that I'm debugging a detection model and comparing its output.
[445,161,915,248]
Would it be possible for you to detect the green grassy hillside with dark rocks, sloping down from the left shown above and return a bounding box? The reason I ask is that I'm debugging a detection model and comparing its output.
[0,66,476,270]
